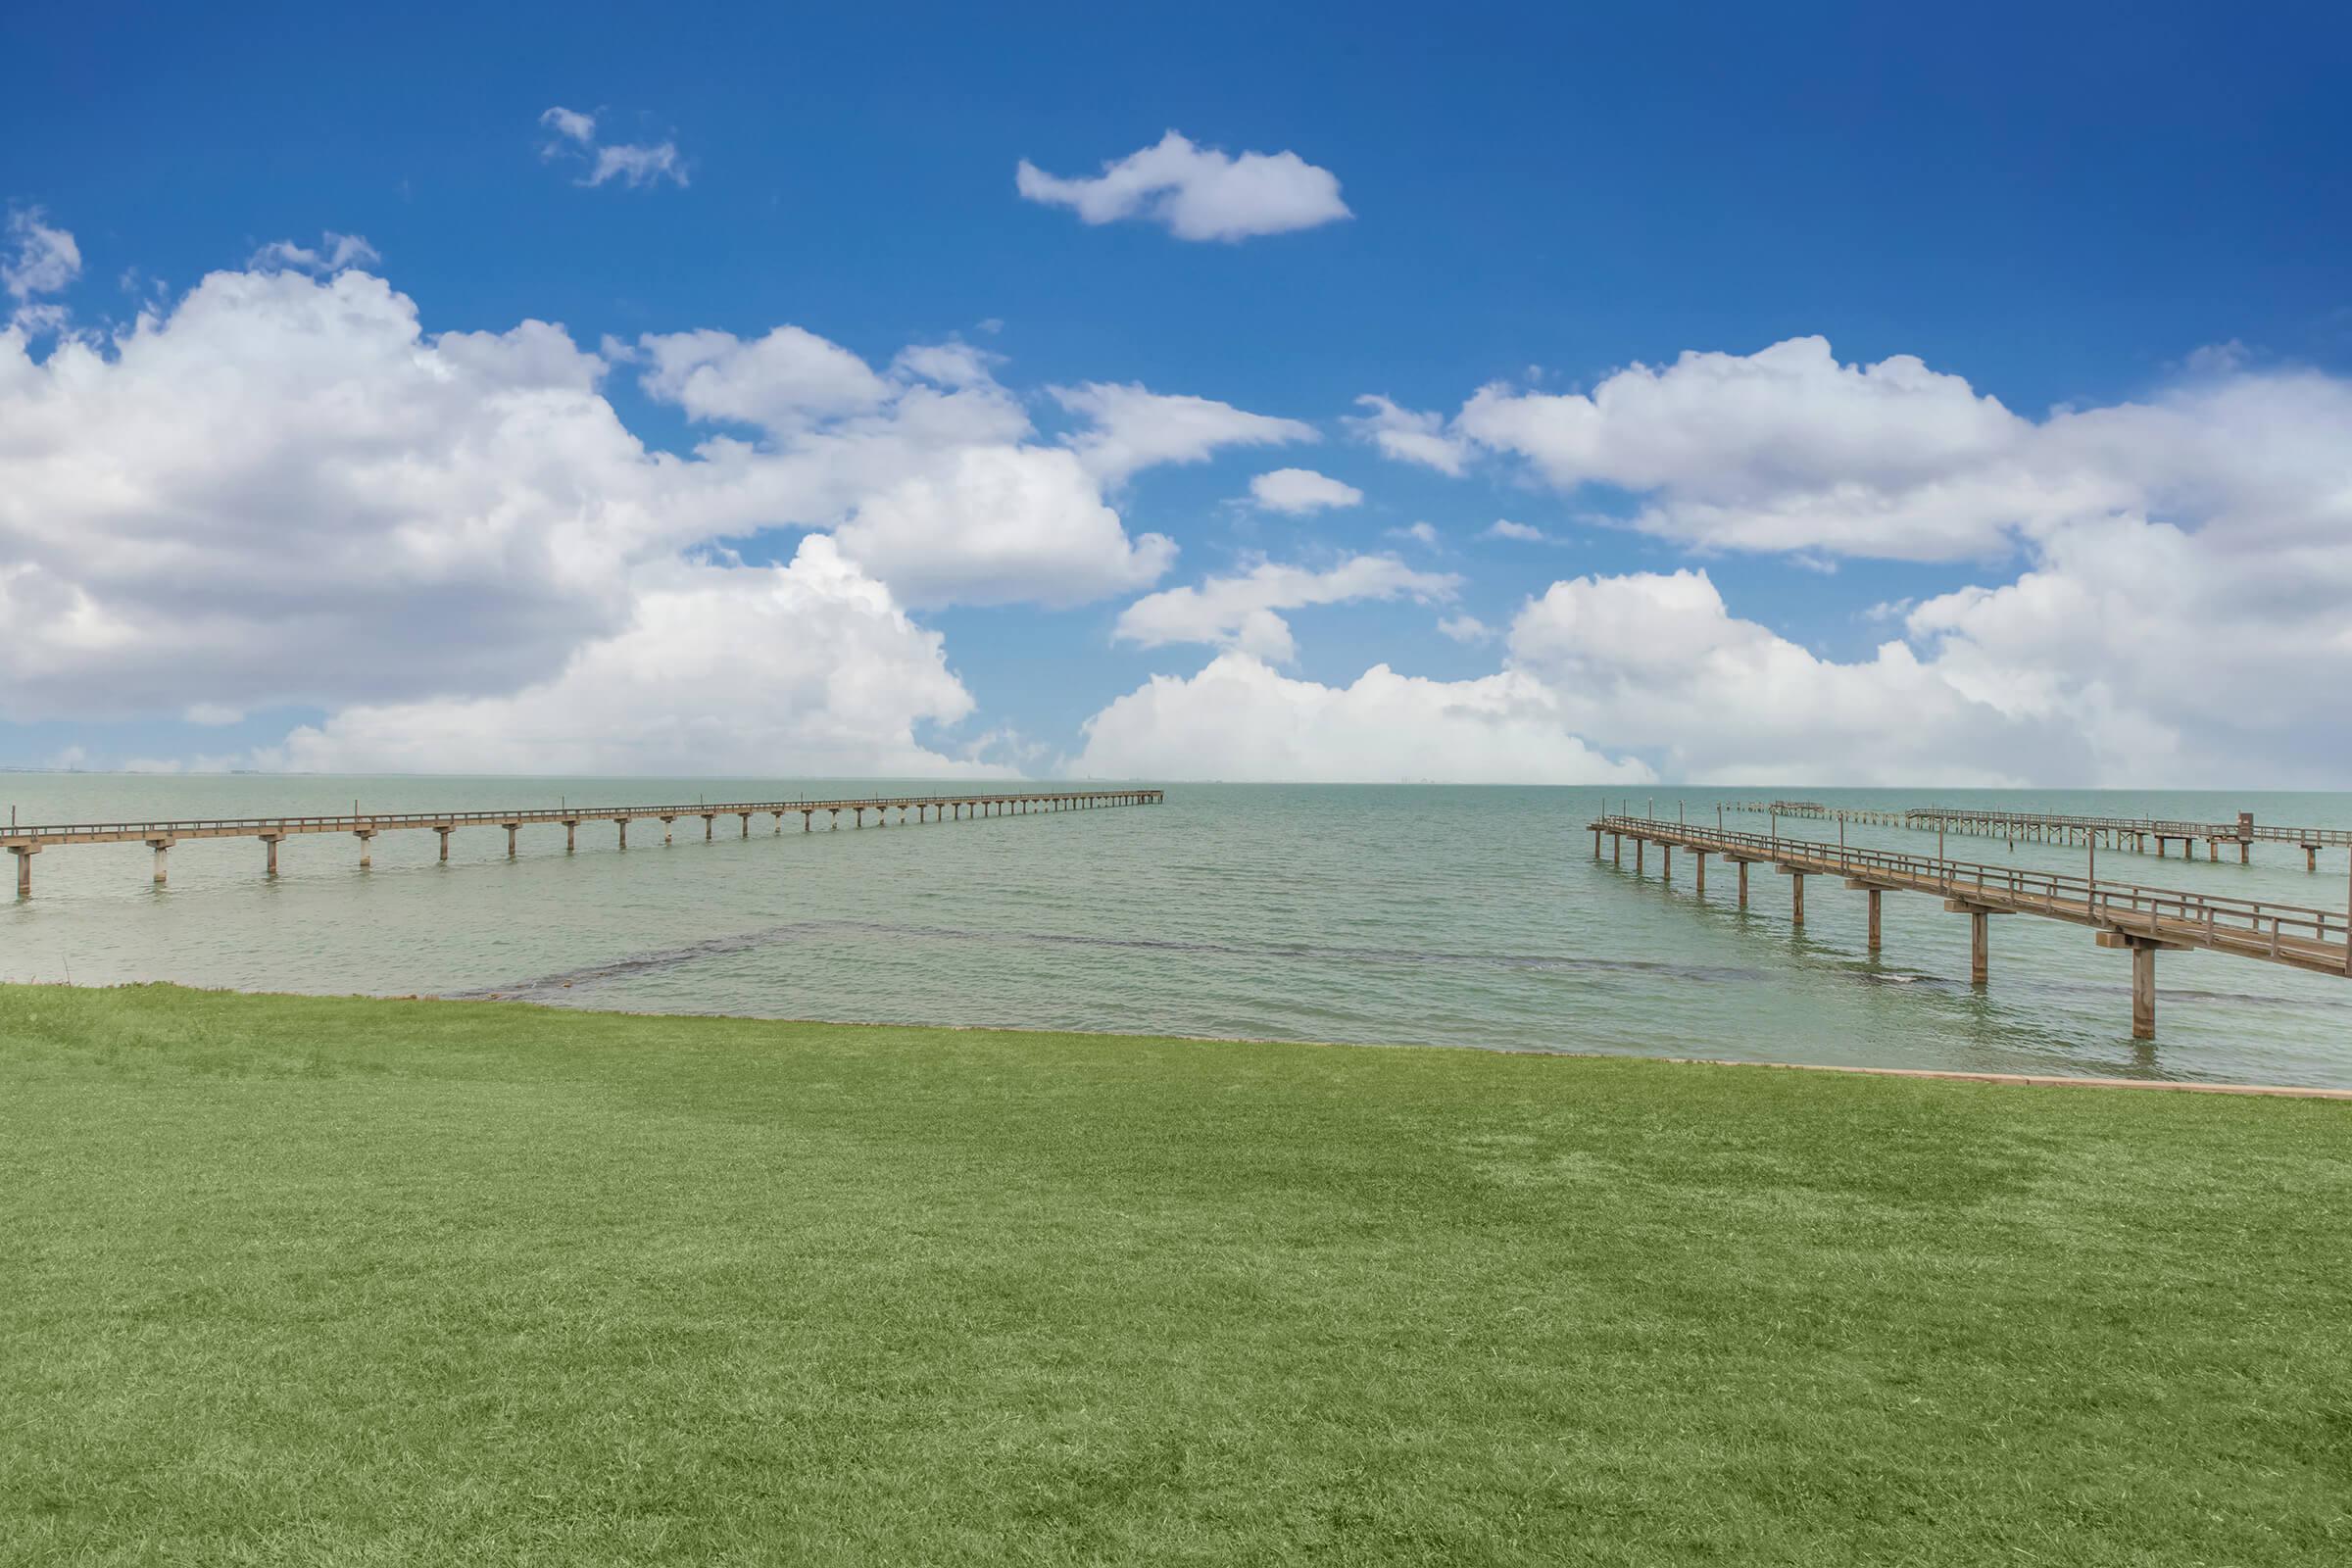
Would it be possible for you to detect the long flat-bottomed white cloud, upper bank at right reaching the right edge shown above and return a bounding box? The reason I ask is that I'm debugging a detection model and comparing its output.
[1448,338,2352,570]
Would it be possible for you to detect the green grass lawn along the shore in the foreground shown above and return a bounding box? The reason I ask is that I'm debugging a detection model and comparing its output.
[0,987,2352,1566]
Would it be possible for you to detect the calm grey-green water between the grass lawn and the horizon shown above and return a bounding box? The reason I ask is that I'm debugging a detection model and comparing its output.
[0,773,2352,1086]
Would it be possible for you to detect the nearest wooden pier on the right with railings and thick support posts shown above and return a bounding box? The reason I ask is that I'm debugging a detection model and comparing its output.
[1590,815,2352,1039]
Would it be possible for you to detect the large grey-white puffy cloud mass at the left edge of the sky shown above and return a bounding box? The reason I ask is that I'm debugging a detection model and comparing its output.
[0,272,672,717]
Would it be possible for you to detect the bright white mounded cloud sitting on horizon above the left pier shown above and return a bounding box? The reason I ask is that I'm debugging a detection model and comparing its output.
[272,536,1002,778]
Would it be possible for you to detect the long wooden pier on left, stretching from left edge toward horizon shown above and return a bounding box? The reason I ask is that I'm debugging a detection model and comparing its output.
[0,790,1166,898]
